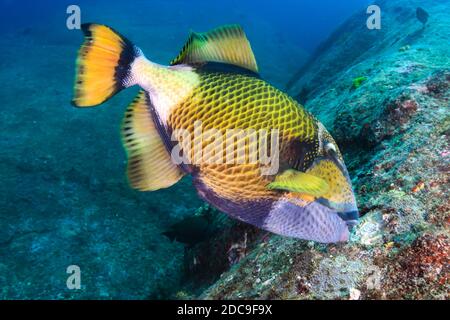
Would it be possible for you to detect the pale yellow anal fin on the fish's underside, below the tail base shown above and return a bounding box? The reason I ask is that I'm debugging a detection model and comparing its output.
[121,90,183,191]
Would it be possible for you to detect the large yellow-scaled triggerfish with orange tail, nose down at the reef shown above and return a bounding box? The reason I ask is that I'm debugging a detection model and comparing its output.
[73,24,358,243]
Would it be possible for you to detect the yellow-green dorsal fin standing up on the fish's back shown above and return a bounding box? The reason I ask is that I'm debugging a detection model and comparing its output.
[170,25,258,72]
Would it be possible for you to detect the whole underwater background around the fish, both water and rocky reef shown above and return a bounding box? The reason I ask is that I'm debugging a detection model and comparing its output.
[0,0,450,299]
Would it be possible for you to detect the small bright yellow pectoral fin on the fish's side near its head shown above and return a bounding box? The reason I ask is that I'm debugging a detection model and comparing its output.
[267,170,329,198]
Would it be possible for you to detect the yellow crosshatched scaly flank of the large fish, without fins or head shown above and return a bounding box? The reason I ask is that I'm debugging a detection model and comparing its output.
[168,73,317,200]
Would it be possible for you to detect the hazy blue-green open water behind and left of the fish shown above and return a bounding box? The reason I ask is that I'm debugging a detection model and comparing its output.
[0,0,368,299]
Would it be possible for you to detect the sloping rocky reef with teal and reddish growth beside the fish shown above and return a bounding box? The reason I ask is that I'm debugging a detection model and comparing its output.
[178,0,450,299]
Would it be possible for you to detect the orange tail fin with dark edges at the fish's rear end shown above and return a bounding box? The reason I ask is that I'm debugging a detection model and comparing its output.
[72,24,139,107]
